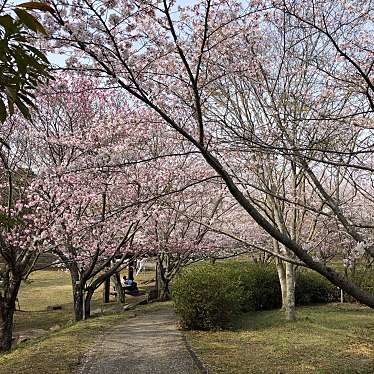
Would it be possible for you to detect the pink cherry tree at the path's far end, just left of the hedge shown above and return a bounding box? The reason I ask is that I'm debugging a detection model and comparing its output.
[143,177,237,300]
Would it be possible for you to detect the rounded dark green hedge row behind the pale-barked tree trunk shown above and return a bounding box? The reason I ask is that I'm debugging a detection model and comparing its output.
[173,261,338,330]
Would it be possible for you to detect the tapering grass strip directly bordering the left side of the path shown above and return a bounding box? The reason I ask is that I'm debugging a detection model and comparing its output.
[0,303,171,374]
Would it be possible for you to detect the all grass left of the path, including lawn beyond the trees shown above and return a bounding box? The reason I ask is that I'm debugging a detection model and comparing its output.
[0,270,159,374]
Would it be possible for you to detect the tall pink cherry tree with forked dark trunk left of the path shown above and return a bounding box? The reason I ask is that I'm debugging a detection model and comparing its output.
[26,75,150,320]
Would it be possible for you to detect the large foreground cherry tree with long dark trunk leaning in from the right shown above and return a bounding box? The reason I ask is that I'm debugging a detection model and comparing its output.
[42,0,374,306]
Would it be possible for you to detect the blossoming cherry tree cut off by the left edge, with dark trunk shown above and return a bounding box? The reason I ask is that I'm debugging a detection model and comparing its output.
[0,118,50,351]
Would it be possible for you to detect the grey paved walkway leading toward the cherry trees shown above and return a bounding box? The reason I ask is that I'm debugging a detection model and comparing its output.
[78,309,200,374]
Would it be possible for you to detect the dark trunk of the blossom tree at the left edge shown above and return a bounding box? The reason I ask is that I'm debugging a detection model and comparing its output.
[0,277,21,352]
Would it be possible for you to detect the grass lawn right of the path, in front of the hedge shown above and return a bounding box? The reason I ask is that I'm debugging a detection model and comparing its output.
[186,304,374,374]
